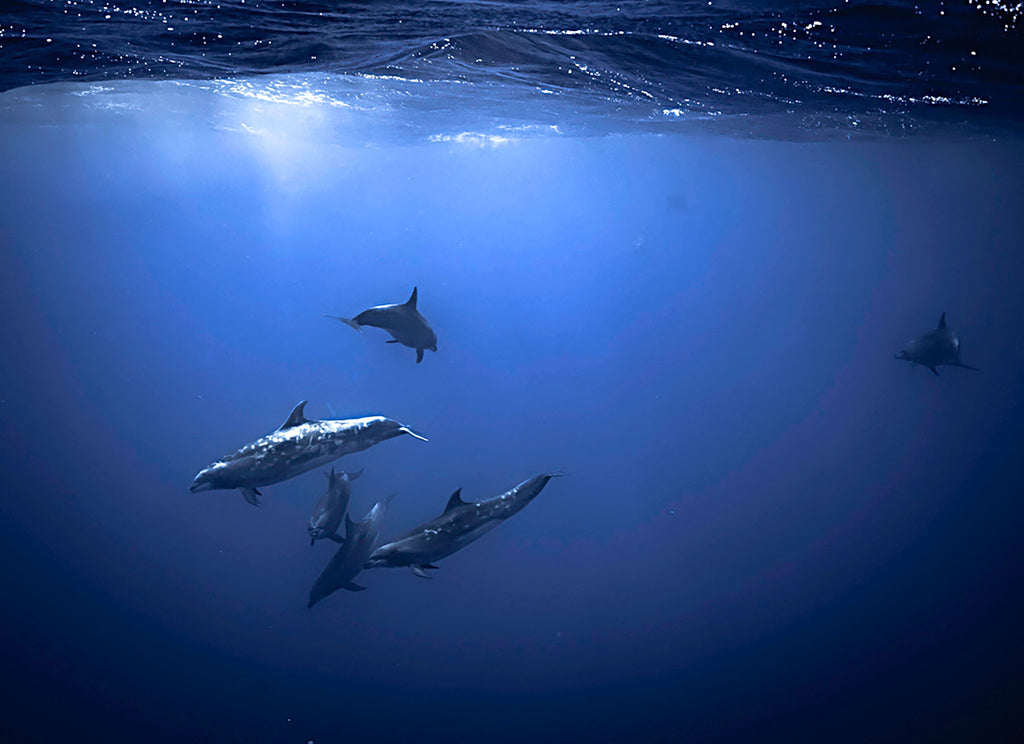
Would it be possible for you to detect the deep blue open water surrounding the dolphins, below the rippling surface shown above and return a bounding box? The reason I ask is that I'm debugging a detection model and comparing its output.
[0,120,1024,741]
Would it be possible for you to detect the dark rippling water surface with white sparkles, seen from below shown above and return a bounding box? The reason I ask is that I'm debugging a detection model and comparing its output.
[0,0,1024,136]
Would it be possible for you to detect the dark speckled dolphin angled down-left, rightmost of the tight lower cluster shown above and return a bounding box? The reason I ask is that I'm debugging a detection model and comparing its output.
[364,473,563,578]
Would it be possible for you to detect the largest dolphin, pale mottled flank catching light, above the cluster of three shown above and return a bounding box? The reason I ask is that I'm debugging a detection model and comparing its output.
[188,400,427,507]
